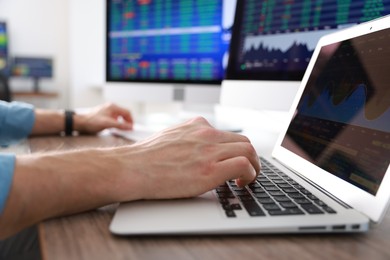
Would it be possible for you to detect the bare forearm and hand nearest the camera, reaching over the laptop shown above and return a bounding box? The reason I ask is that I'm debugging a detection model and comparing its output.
[0,118,260,237]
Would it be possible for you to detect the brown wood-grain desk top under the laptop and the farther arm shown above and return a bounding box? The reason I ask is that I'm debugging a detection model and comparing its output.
[29,136,390,260]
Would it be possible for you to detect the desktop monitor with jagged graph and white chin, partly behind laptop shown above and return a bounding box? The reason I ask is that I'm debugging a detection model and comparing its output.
[220,0,390,111]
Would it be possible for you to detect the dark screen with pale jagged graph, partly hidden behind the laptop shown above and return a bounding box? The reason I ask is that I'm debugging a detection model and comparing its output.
[226,0,390,81]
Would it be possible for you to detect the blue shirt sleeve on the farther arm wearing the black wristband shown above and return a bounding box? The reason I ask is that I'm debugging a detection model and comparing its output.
[0,101,35,146]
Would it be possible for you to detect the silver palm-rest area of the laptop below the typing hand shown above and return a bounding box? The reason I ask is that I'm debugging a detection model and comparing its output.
[110,192,224,235]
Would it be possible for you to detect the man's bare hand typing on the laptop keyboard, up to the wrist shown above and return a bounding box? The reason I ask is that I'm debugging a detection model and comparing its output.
[110,118,260,201]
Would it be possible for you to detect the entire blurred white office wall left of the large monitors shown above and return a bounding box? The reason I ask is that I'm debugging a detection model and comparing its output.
[0,0,105,108]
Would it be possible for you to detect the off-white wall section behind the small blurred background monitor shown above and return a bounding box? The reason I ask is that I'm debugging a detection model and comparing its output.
[0,0,70,107]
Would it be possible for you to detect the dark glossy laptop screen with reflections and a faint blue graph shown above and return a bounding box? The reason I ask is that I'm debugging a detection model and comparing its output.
[282,29,390,195]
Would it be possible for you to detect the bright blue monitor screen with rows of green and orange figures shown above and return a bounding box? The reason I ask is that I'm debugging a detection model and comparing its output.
[106,0,234,84]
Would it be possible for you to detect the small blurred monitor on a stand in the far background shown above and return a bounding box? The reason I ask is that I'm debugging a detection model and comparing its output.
[12,57,53,92]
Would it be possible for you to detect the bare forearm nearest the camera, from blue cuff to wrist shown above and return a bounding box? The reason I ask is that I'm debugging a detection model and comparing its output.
[0,149,137,237]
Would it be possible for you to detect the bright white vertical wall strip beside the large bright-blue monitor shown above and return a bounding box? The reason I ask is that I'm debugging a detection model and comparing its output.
[68,0,105,107]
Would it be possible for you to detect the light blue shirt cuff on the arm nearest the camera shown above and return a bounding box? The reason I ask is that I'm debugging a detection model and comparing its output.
[0,154,15,215]
